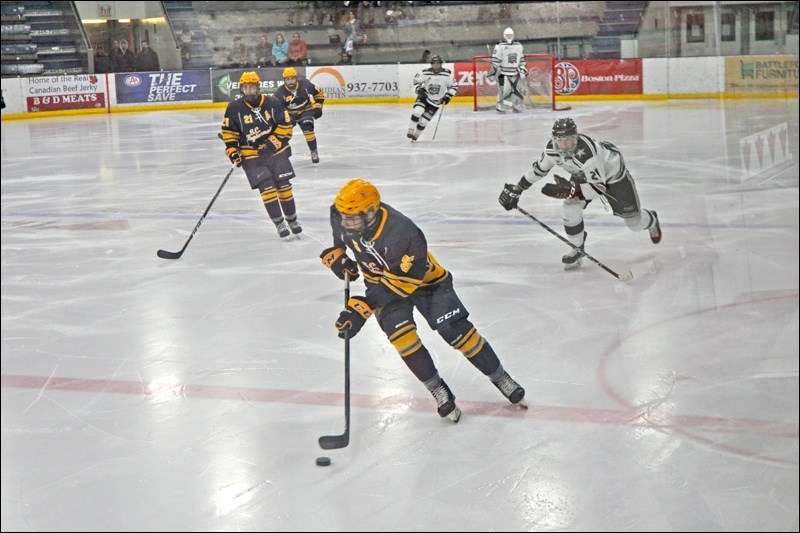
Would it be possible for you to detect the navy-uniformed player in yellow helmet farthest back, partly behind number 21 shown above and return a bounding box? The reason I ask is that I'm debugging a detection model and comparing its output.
[275,67,325,163]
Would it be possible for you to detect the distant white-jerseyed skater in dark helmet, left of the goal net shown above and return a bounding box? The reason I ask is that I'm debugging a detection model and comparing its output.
[406,55,458,142]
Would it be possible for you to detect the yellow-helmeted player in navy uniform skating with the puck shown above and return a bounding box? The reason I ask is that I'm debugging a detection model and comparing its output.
[320,178,525,422]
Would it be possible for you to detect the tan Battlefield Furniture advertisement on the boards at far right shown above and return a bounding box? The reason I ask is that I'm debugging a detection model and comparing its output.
[725,55,798,92]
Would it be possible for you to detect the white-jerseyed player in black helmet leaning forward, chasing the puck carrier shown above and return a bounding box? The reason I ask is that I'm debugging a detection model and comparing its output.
[499,118,661,270]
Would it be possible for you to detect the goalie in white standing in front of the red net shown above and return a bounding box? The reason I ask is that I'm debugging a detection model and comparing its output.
[488,28,528,113]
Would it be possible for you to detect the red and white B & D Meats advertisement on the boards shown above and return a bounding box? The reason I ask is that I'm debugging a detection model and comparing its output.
[24,74,106,113]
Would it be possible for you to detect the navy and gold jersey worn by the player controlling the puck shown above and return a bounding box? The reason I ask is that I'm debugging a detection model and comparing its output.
[331,202,450,308]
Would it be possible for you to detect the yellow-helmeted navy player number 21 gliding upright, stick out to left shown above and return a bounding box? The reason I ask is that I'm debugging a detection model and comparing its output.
[221,71,303,239]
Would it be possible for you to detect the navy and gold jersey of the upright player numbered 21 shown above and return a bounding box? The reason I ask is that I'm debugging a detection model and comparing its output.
[222,94,293,159]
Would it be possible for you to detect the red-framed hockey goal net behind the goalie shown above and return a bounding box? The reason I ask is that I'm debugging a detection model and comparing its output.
[472,54,570,111]
